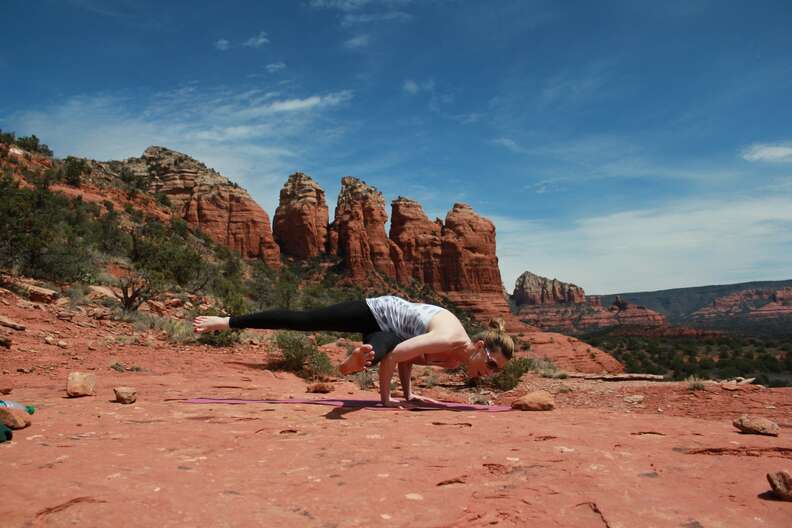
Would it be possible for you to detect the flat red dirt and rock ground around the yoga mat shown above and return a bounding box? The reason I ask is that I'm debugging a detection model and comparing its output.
[0,292,792,528]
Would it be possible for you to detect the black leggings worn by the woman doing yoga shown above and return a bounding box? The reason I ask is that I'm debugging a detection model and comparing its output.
[228,301,402,364]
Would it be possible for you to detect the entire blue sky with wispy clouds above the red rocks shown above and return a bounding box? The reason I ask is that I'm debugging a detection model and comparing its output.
[0,0,792,294]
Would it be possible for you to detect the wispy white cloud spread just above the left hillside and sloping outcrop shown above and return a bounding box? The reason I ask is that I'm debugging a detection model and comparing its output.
[7,86,353,215]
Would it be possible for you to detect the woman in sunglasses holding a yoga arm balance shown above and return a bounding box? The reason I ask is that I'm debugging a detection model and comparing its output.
[193,296,514,407]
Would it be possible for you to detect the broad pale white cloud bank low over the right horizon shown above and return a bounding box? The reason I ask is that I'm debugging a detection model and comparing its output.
[496,194,792,294]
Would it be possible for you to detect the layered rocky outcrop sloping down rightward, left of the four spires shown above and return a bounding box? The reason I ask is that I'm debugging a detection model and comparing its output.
[122,147,280,268]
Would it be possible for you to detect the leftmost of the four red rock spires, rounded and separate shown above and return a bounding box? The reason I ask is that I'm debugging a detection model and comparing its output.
[272,172,328,258]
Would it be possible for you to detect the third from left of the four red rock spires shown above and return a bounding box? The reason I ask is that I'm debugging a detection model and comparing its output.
[390,196,443,291]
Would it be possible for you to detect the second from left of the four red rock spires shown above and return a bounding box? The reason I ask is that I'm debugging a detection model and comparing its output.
[328,176,398,280]
